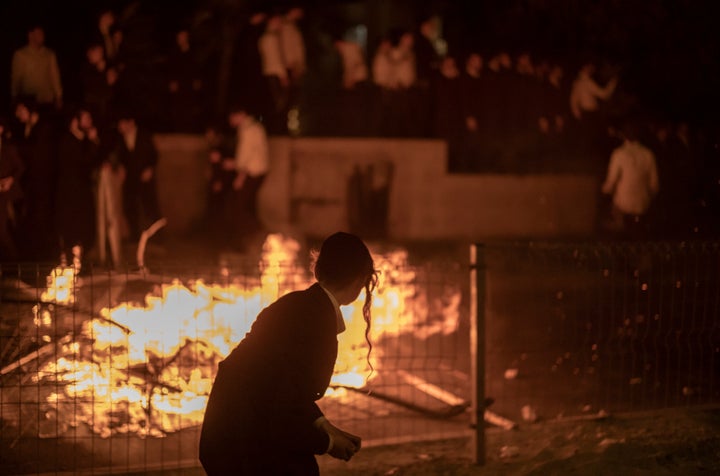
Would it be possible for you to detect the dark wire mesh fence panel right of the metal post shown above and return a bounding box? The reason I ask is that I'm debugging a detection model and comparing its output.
[478,242,720,426]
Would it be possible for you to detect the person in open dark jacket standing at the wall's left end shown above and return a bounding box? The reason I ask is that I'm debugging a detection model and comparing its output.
[112,112,161,240]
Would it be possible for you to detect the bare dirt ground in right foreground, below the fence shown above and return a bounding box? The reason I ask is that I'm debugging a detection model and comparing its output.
[319,408,720,476]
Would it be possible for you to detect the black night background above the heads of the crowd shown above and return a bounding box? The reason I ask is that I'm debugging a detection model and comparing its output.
[0,0,720,125]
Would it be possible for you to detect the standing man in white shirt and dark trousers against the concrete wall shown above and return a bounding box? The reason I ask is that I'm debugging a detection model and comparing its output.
[226,107,270,248]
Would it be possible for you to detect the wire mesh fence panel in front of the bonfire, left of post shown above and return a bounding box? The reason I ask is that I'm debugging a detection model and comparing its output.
[0,242,469,474]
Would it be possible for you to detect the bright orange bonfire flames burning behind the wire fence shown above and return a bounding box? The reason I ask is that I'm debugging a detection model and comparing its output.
[25,235,460,437]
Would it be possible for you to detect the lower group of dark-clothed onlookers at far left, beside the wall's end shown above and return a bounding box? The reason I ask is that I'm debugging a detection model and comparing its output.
[0,98,161,265]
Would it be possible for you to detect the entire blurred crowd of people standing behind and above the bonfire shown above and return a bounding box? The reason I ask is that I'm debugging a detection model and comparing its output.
[0,6,714,261]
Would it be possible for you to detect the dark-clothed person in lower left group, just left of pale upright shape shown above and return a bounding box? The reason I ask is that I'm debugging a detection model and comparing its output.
[55,109,100,262]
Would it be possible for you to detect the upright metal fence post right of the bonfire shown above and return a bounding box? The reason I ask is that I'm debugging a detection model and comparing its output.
[470,244,485,465]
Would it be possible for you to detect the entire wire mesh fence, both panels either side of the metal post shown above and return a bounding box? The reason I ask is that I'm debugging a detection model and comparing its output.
[0,242,720,474]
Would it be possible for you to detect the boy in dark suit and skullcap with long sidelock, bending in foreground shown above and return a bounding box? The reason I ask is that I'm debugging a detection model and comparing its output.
[199,232,377,476]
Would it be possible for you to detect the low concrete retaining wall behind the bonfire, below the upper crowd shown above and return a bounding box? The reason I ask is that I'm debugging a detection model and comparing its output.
[156,135,598,241]
